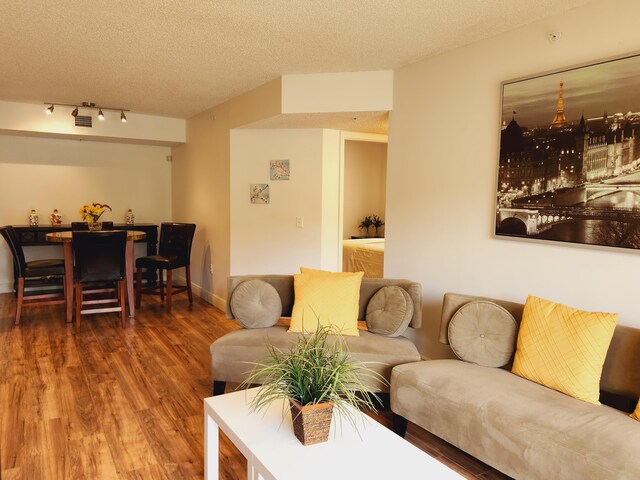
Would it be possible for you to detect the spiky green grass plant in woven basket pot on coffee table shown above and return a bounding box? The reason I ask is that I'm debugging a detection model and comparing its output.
[242,326,387,445]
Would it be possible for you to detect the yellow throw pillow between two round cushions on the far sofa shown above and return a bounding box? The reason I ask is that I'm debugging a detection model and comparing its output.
[289,270,362,336]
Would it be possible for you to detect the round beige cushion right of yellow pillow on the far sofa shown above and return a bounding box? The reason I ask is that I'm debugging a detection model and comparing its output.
[366,286,413,337]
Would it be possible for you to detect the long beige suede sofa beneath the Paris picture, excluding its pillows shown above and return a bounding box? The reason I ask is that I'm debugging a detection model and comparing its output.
[391,294,640,480]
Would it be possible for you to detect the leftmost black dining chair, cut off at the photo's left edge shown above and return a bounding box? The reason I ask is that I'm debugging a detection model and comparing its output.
[0,225,65,325]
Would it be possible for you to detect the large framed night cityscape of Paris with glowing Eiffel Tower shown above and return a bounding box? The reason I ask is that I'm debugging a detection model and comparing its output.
[495,55,640,249]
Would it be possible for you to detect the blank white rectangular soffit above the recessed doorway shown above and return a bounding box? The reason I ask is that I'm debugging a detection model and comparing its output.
[282,70,394,114]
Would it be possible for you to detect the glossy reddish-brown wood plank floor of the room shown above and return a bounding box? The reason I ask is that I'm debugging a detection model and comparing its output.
[0,294,508,480]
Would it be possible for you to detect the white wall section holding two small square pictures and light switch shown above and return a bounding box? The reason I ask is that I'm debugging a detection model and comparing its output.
[231,129,323,275]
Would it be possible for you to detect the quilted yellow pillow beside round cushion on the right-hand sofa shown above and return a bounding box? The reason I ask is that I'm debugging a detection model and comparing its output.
[511,295,618,405]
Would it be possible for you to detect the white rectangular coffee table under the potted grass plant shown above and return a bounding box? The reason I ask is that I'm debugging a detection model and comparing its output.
[204,388,464,480]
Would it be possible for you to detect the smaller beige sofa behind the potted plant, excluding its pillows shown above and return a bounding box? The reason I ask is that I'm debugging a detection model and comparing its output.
[210,275,422,395]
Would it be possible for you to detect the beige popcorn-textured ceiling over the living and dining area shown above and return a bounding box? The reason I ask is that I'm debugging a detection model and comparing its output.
[0,0,591,118]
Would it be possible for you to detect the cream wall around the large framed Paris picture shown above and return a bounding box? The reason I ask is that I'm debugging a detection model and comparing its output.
[385,0,640,356]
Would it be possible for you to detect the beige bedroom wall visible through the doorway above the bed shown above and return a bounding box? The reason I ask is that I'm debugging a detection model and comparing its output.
[343,140,387,238]
